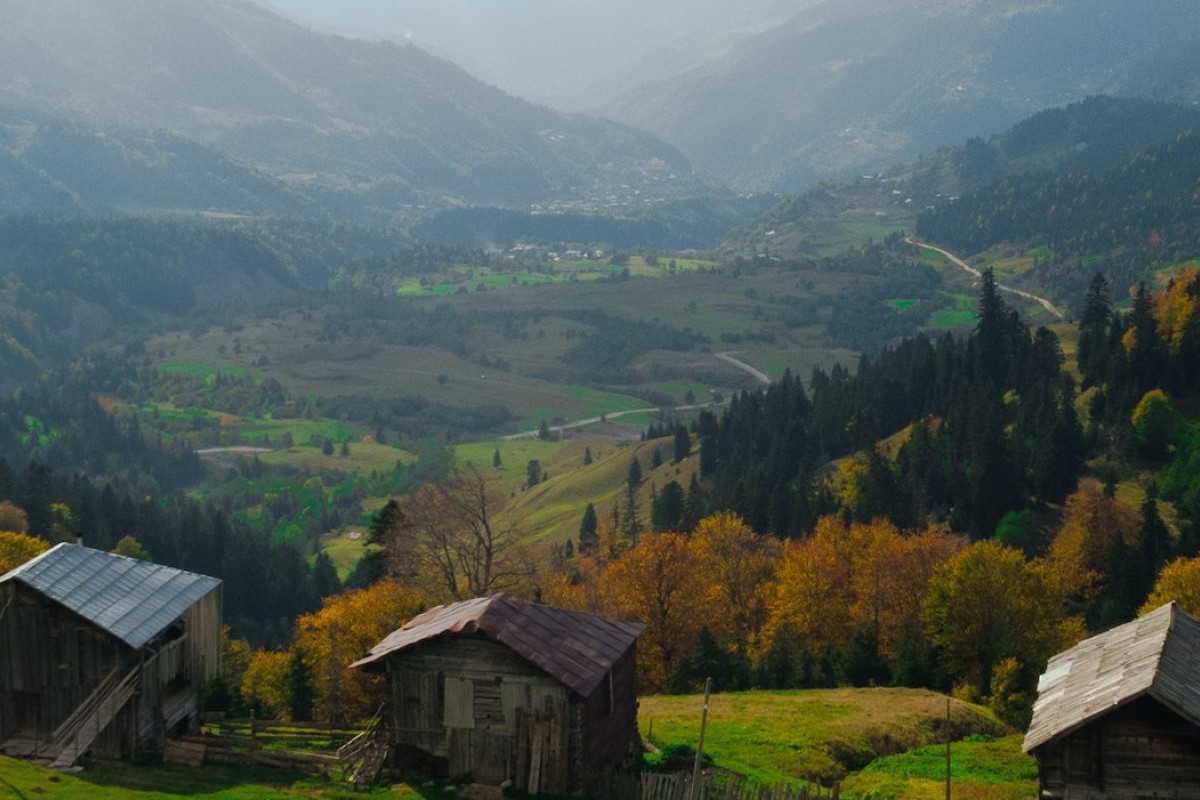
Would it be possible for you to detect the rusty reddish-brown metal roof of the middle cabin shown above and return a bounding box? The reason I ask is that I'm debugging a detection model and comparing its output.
[353,594,644,697]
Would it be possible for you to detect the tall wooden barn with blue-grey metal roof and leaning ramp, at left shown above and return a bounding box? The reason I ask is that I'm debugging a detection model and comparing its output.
[0,545,221,768]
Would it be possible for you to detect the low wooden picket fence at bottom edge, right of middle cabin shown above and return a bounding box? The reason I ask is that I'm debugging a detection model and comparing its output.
[586,772,838,800]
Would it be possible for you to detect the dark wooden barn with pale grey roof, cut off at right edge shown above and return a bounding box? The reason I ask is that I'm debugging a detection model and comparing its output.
[1025,603,1200,800]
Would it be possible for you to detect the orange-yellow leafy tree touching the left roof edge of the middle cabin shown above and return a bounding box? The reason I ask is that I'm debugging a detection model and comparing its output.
[295,581,428,724]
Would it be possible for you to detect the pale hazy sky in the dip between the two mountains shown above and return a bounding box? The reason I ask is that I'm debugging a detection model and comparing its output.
[254,0,815,112]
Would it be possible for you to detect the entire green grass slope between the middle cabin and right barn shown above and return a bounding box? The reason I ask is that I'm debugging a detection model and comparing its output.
[638,688,1037,800]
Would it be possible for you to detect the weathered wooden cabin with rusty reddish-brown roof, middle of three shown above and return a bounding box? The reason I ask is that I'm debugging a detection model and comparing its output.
[355,594,643,794]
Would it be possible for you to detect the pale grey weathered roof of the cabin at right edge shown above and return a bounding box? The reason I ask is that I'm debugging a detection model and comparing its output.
[1025,603,1200,752]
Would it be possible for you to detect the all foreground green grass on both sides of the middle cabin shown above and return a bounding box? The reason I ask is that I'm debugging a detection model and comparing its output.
[0,688,1037,800]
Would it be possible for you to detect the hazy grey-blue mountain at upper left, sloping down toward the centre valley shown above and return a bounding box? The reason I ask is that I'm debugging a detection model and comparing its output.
[0,0,700,215]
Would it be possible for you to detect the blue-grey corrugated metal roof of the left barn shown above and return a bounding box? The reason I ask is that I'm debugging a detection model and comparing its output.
[0,543,221,649]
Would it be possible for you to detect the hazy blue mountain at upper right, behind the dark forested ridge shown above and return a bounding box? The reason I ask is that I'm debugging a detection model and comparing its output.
[606,0,1200,191]
